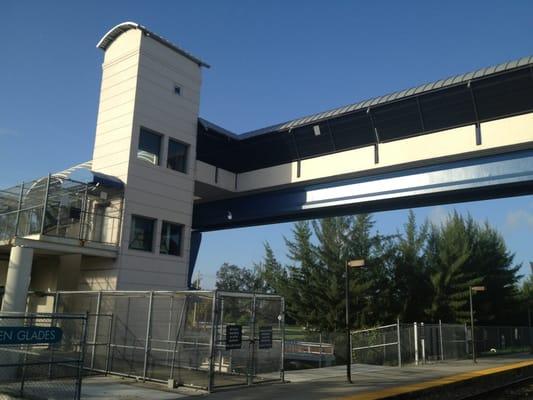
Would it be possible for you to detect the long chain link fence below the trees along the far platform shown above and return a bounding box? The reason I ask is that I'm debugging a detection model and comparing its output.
[285,321,533,369]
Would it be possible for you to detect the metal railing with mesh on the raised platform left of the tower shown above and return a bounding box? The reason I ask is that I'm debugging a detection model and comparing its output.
[0,175,122,245]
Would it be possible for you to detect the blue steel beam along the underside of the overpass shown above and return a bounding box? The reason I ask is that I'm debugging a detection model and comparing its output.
[193,150,533,231]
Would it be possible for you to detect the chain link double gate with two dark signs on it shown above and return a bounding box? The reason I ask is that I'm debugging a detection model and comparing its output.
[209,292,285,389]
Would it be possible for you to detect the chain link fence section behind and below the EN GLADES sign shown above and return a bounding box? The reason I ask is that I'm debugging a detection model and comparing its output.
[0,313,87,399]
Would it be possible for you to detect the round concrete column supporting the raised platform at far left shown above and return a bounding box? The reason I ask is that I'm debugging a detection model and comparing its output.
[2,246,33,312]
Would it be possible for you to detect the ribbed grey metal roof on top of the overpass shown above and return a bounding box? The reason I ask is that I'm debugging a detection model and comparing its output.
[204,56,533,139]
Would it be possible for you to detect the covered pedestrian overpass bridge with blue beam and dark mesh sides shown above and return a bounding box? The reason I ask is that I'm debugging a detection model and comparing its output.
[193,58,533,231]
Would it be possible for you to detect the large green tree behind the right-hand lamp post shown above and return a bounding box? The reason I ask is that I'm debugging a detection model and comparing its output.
[426,212,520,324]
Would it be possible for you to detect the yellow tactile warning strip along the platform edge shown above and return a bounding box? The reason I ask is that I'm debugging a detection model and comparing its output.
[340,361,533,400]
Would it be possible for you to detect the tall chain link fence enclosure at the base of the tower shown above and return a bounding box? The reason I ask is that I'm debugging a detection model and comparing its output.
[41,291,284,390]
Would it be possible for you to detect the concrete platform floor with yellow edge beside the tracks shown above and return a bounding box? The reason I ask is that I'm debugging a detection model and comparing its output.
[82,355,533,400]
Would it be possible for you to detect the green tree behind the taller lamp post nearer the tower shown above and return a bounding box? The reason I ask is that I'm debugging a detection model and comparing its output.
[283,215,394,332]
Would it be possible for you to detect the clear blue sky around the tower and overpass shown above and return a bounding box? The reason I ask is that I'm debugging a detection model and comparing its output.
[0,0,533,286]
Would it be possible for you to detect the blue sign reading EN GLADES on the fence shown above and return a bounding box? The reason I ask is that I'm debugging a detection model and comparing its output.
[0,326,63,345]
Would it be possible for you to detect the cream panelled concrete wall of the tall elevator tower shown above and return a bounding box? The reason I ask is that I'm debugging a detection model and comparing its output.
[91,29,201,290]
